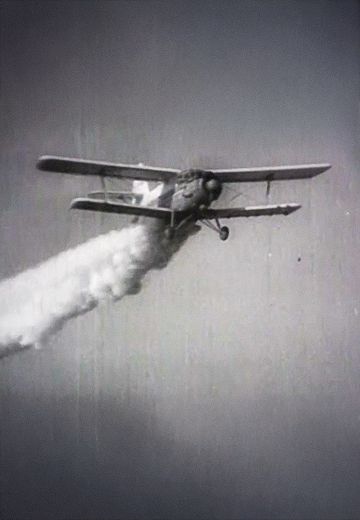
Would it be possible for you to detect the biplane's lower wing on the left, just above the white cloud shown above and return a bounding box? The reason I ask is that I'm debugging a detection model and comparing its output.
[70,198,171,222]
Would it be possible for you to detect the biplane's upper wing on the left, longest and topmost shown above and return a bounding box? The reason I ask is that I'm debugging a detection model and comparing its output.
[36,155,180,182]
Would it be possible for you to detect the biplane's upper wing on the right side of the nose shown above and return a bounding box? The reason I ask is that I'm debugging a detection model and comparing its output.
[211,164,331,182]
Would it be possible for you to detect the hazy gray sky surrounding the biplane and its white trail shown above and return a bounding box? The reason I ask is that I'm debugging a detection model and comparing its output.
[0,0,360,519]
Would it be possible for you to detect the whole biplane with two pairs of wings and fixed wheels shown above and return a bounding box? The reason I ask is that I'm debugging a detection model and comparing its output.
[37,155,330,240]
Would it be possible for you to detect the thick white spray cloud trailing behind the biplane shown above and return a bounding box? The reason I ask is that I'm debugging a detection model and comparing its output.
[0,221,199,358]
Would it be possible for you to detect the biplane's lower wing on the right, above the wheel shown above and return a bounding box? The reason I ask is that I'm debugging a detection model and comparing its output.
[201,203,301,220]
